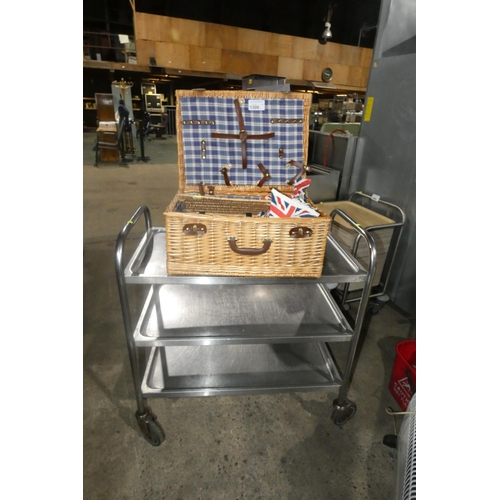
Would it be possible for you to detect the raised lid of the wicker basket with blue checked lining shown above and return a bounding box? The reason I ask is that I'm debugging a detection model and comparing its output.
[176,90,311,193]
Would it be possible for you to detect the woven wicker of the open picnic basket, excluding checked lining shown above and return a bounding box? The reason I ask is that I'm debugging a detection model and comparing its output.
[164,91,330,278]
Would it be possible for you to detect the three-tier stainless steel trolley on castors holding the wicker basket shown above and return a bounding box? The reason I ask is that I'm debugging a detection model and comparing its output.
[115,205,376,446]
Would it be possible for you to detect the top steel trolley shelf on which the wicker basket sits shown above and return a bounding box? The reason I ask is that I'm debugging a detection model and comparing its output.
[124,227,367,285]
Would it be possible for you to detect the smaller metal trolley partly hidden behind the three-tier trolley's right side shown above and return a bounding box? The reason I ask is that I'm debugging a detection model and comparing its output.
[332,191,406,316]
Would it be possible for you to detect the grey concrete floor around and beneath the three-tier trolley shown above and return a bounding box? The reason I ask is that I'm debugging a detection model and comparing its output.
[83,132,415,500]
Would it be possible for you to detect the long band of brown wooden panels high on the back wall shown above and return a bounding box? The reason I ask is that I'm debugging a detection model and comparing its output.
[135,12,373,87]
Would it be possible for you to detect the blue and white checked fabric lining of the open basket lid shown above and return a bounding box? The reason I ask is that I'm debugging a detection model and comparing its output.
[180,97,308,186]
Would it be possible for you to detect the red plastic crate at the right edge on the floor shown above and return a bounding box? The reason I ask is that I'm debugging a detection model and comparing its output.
[389,340,417,411]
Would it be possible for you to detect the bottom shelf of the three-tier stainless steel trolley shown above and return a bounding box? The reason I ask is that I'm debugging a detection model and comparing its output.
[141,342,341,398]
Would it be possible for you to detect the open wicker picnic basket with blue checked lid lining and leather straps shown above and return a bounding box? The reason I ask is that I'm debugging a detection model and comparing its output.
[164,90,331,278]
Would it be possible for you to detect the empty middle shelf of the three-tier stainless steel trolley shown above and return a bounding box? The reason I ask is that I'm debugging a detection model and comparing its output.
[134,283,353,347]
